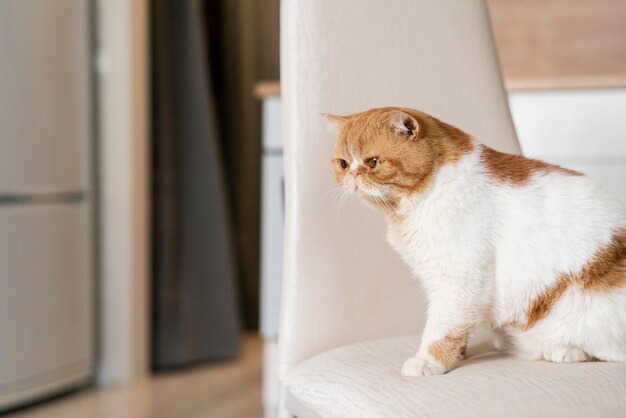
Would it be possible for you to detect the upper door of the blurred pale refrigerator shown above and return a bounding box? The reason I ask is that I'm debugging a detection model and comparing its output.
[0,0,92,193]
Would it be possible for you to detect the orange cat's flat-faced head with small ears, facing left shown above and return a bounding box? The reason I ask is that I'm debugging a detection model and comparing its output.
[325,108,471,207]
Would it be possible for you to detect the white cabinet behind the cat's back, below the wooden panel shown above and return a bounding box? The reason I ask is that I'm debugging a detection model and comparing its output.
[509,89,626,203]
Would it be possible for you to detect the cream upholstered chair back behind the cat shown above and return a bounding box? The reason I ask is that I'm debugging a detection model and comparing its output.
[279,0,519,375]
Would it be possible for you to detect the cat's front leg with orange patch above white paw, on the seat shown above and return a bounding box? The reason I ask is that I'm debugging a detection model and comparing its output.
[402,301,477,376]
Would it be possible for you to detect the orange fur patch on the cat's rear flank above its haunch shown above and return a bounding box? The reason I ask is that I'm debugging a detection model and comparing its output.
[523,228,626,330]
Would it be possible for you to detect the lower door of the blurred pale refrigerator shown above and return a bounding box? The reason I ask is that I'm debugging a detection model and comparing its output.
[0,203,94,409]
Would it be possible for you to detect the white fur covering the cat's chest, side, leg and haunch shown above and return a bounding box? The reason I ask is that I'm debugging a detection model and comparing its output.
[346,143,626,375]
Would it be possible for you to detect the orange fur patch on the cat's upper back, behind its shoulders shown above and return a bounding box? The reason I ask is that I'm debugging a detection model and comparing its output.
[482,146,582,186]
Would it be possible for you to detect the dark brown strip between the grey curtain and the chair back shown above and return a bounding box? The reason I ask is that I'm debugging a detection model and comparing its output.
[204,0,280,329]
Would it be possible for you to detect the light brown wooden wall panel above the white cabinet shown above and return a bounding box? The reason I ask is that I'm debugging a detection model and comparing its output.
[488,0,626,89]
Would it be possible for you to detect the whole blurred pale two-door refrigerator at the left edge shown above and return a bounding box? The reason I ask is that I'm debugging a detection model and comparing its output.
[0,0,95,411]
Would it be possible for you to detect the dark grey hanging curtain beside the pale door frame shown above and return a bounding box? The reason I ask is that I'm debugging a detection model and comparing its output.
[152,0,240,368]
